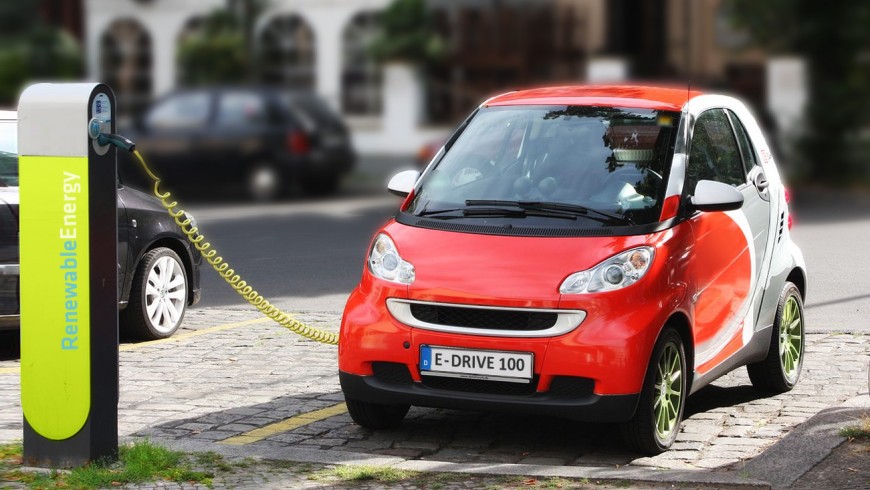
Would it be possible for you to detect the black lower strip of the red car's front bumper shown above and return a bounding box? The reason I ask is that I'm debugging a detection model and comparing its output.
[338,371,639,422]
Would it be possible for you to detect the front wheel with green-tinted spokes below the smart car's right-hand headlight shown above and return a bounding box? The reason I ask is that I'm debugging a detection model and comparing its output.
[622,326,688,455]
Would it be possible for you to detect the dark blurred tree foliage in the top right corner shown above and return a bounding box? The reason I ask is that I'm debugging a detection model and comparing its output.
[728,0,870,182]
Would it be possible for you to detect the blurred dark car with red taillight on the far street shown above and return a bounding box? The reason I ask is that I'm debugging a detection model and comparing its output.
[122,88,356,200]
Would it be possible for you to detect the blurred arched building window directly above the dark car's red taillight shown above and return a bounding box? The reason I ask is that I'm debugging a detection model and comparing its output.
[259,15,315,90]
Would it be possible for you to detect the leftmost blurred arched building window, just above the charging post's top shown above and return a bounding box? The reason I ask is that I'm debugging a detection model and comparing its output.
[100,19,153,118]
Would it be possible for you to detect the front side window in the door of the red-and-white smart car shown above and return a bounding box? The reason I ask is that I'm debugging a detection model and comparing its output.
[686,109,746,194]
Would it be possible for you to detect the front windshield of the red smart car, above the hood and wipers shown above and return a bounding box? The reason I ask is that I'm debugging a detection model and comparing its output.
[406,106,679,227]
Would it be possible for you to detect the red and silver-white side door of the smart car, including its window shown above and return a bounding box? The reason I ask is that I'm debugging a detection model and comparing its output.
[686,109,769,373]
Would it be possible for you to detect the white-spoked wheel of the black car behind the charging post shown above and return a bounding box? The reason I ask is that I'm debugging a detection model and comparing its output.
[120,247,187,340]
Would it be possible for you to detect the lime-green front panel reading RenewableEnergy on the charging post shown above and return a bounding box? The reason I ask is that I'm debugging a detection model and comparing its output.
[19,156,91,440]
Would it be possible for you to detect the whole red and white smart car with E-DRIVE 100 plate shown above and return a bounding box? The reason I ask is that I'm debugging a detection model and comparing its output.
[338,86,807,454]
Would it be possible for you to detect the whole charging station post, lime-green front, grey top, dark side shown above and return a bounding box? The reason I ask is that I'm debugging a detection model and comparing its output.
[18,83,118,468]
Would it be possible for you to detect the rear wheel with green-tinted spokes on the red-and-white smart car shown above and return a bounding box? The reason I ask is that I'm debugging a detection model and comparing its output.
[746,282,806,393]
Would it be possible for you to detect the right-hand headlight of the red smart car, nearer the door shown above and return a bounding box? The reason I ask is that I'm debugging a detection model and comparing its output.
[559,247,655,294]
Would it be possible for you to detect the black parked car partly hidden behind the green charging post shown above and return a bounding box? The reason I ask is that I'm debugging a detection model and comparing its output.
[0,111,202,339]
